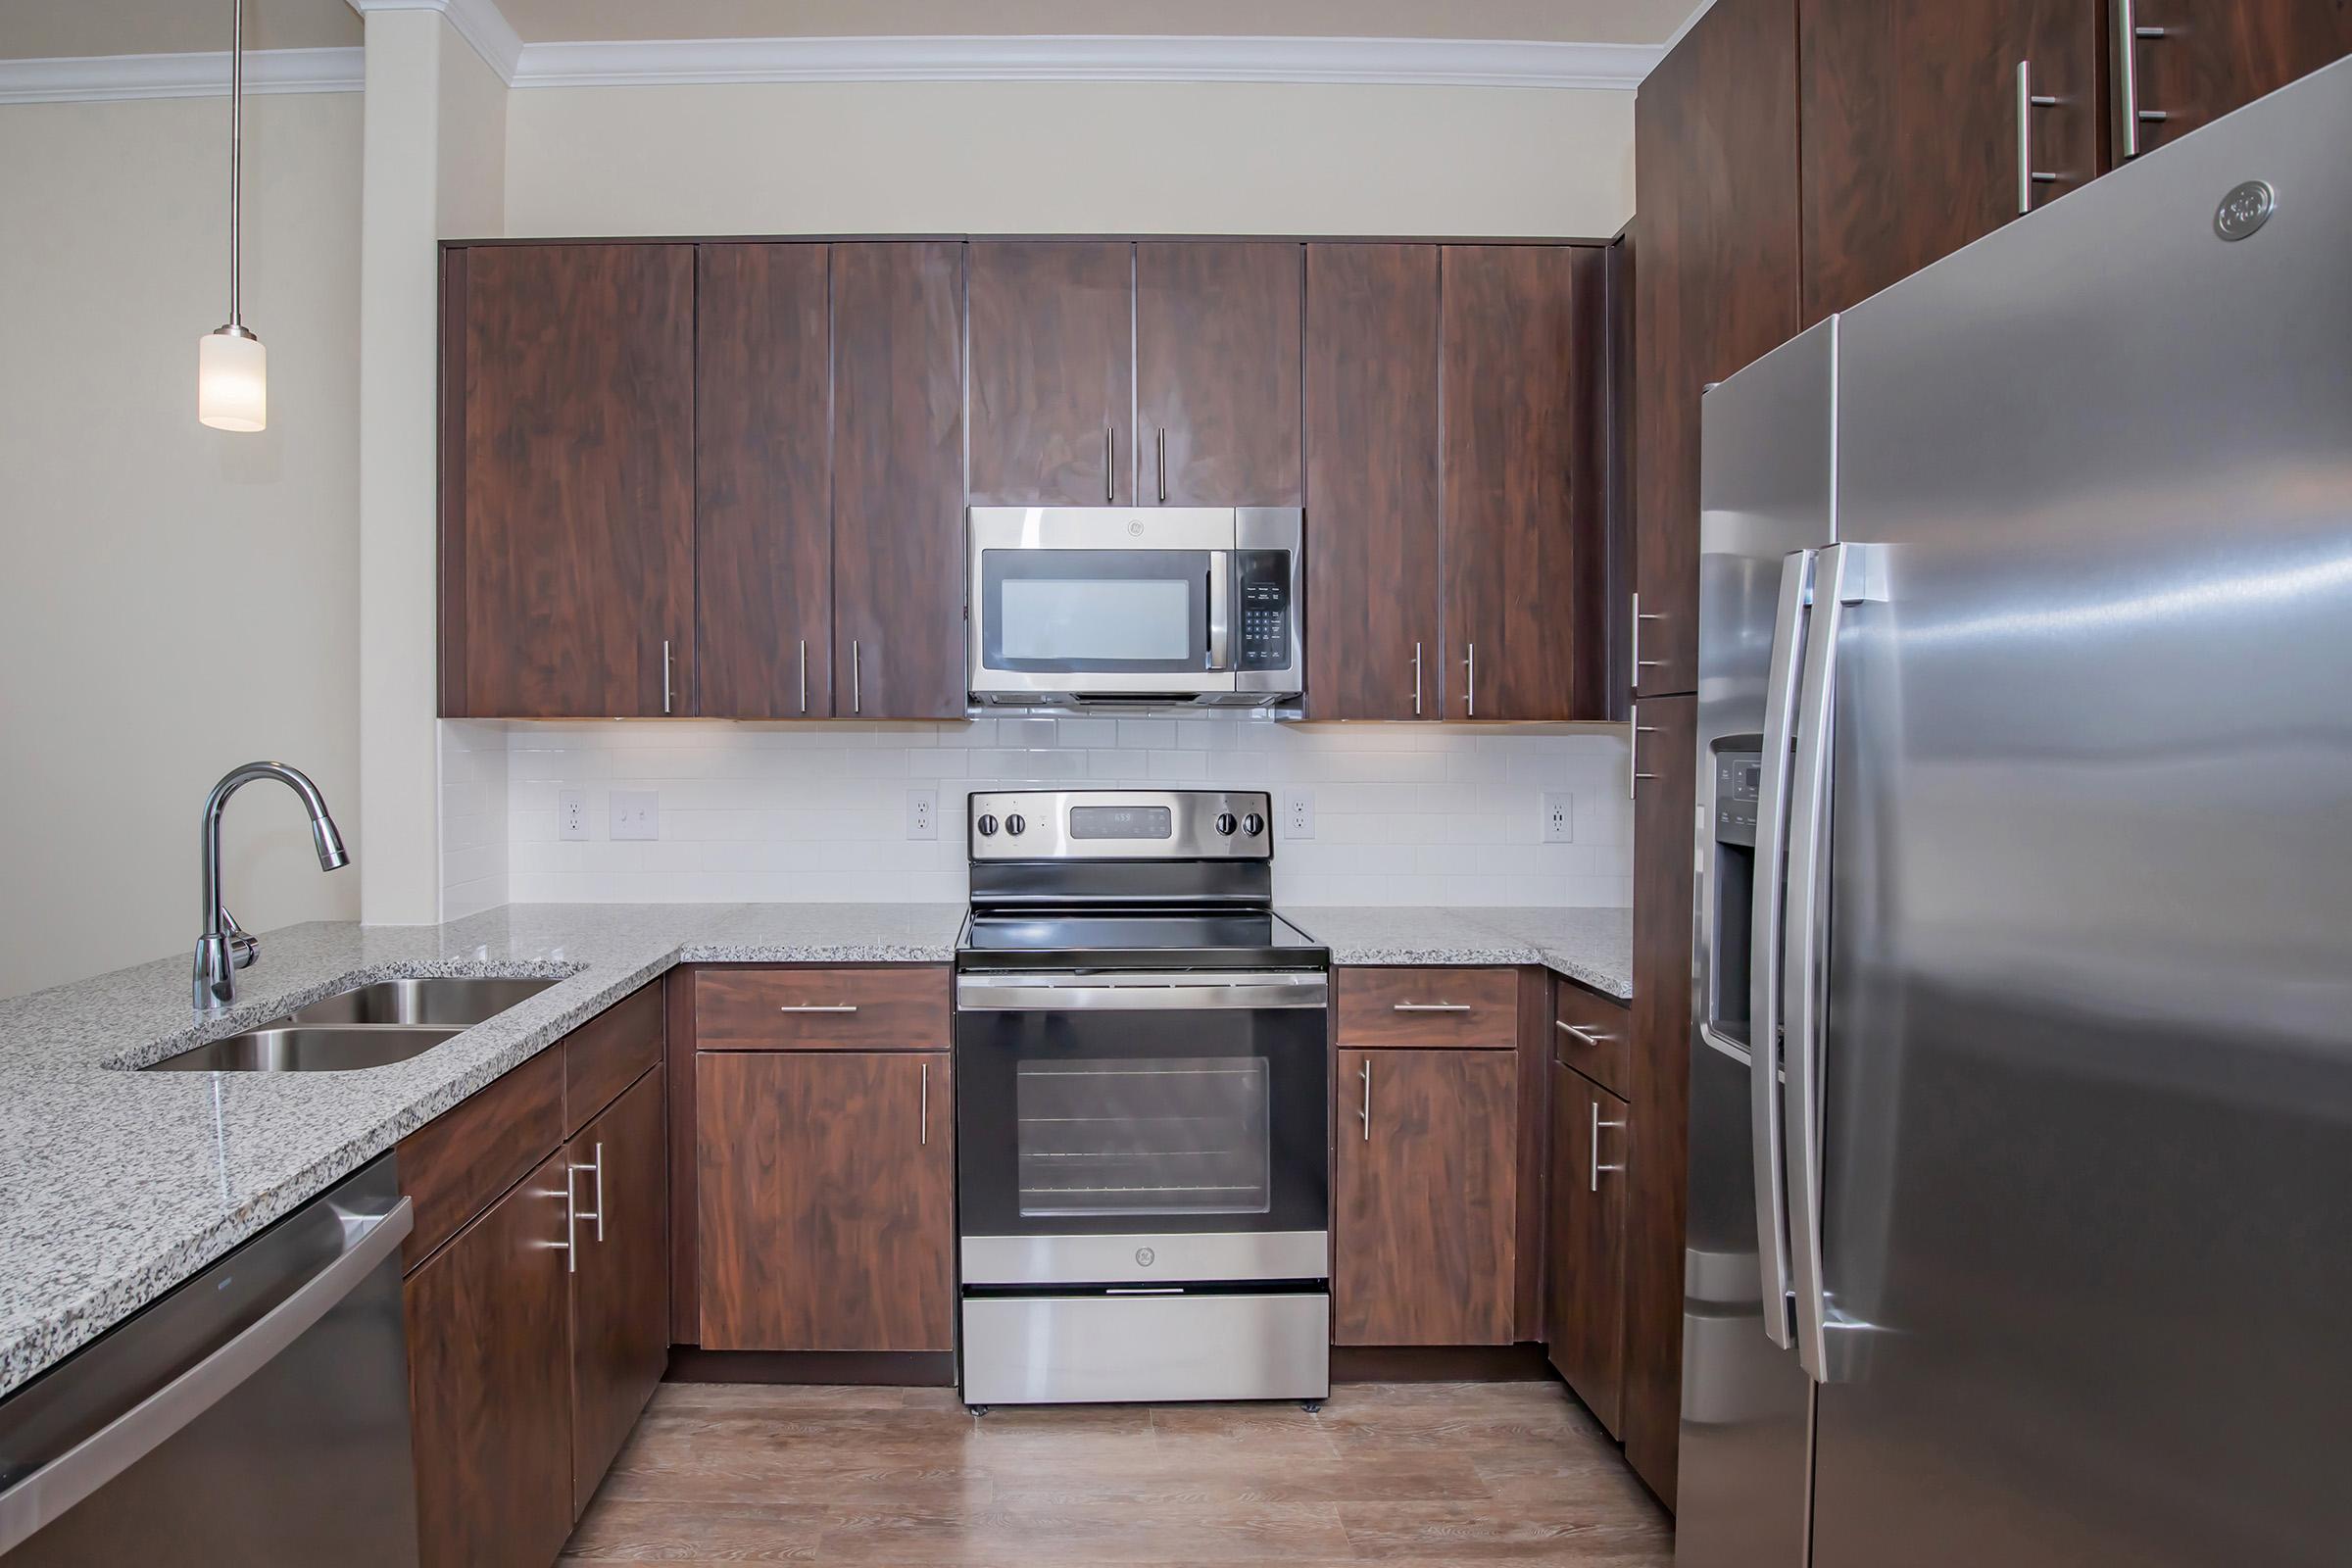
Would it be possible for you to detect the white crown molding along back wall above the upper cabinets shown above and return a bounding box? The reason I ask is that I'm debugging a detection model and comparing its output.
[506,35,1660,92]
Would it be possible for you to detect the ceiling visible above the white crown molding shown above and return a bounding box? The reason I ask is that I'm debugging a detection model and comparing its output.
[0,0,1698,59]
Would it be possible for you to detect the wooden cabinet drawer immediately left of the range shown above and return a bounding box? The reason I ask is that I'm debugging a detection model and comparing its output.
[694,964,951,1051]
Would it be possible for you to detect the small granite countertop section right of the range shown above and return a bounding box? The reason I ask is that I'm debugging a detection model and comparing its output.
[1282,906,1633,1002]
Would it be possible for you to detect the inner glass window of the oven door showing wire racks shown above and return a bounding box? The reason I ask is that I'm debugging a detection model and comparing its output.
[1013,1055,1272,1220]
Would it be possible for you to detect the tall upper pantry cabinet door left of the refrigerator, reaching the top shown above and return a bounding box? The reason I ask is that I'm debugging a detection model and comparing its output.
[1633,0,1799,696]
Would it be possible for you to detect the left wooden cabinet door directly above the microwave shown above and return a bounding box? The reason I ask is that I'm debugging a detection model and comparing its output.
[971,240,1136,506]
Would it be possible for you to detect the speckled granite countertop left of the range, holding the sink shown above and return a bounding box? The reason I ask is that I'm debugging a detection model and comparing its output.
[0,906,964,1394]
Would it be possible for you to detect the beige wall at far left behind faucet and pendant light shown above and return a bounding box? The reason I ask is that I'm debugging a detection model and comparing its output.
[0,94,374,995]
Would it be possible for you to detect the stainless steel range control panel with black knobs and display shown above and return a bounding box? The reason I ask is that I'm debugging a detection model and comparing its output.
[966,790,1275,860]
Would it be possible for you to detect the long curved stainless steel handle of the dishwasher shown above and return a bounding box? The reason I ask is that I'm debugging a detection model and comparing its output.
[0,1199,416,1556]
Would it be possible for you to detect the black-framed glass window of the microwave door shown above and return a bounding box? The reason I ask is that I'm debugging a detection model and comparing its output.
[981,550,1209,674]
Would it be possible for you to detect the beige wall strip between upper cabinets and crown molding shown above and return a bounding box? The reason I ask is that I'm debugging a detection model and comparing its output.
[506,82,1633,235]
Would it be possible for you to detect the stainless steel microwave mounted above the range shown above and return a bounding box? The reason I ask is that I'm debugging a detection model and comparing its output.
[966,506,1307,708]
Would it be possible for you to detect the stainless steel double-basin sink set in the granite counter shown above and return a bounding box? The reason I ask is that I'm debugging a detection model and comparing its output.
[146,976,558,1072]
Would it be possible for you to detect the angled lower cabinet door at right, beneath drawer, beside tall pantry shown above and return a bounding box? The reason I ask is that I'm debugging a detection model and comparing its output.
[1543,1062,1630,1437]
